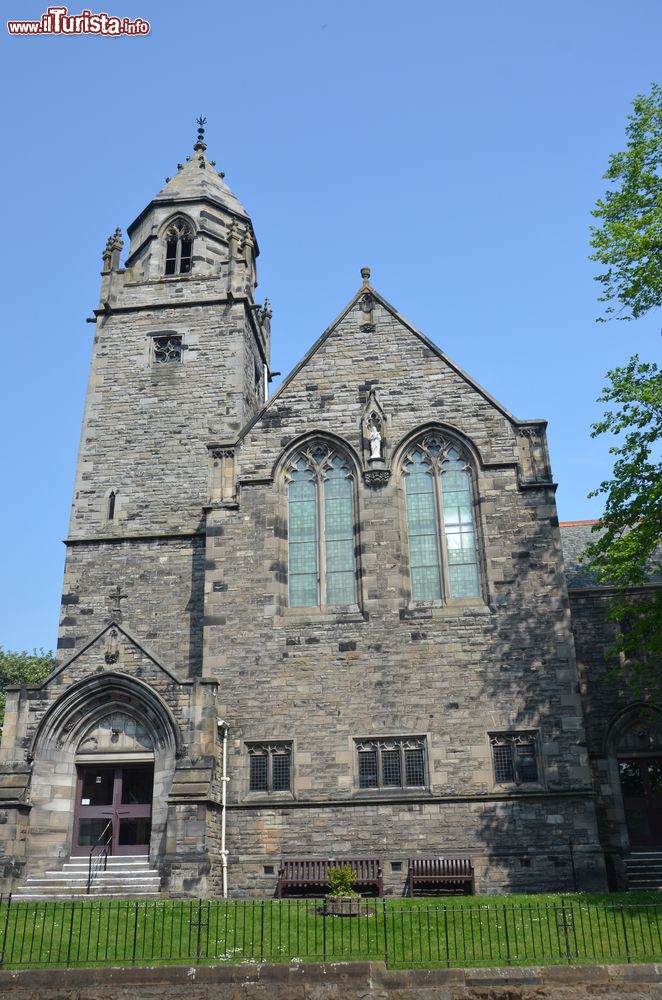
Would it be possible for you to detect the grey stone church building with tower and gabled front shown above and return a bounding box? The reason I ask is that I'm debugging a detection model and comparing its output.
[0,123,662,898]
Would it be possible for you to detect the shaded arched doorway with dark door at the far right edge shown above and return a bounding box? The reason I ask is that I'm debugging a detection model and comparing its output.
[610,706,662,850]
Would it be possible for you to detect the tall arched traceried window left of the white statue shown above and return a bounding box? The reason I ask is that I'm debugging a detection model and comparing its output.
[287,441,357,608]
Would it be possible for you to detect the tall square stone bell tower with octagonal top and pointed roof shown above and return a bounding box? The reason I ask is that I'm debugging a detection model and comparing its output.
[58,118,271,675]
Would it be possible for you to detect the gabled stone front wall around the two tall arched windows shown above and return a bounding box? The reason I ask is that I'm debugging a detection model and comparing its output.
[204,292,604,893]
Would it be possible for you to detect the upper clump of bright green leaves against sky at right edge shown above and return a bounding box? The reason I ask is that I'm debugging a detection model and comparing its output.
[591,83,662,322]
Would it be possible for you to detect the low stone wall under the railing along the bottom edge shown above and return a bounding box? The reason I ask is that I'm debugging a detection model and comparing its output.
[0,962,662,1000]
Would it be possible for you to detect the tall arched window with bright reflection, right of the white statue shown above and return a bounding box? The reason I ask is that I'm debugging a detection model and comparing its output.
[403,433,481,601]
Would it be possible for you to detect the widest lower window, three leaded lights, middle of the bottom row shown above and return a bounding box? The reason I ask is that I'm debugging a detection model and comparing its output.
[356,736,426,788]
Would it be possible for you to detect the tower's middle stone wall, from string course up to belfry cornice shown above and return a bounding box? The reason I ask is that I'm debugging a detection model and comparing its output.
[70,294,263,539]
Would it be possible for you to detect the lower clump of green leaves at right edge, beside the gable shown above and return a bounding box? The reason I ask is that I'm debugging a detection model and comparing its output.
[587,355,662,697]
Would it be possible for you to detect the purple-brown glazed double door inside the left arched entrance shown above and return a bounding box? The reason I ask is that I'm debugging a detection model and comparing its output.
[71,763,154,855]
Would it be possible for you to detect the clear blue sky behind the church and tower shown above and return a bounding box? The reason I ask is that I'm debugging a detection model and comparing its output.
[0,0,662,649]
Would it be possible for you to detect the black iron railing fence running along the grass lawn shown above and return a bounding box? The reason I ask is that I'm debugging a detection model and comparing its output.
[0,897,662,968]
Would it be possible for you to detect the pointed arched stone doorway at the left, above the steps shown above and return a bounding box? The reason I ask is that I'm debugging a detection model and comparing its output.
[30,671,183,861]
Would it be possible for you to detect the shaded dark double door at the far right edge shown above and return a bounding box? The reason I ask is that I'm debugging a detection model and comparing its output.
[618,757,662,848]
